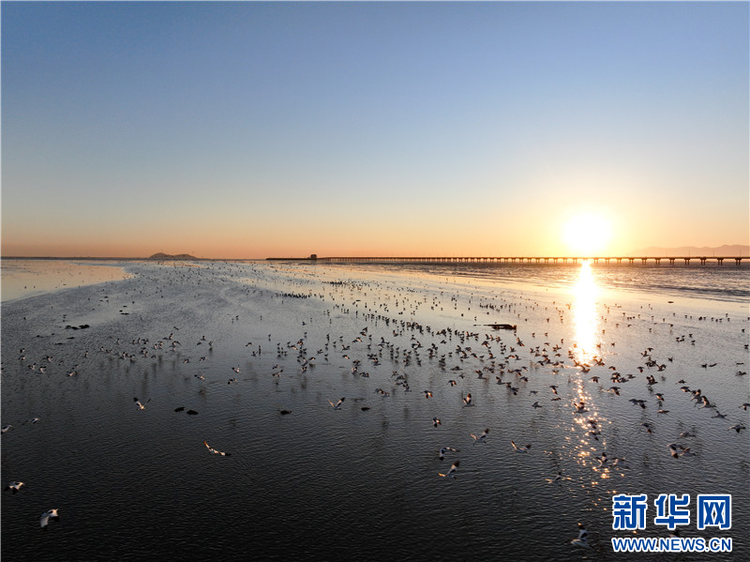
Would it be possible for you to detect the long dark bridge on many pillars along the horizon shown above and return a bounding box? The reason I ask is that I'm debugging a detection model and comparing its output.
[267,254,750,266]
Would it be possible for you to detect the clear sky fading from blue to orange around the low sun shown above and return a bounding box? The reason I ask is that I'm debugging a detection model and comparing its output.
[0,1,750,259]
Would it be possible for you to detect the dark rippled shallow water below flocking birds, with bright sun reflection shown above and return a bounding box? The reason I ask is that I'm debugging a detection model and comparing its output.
[2,263,750,560]
